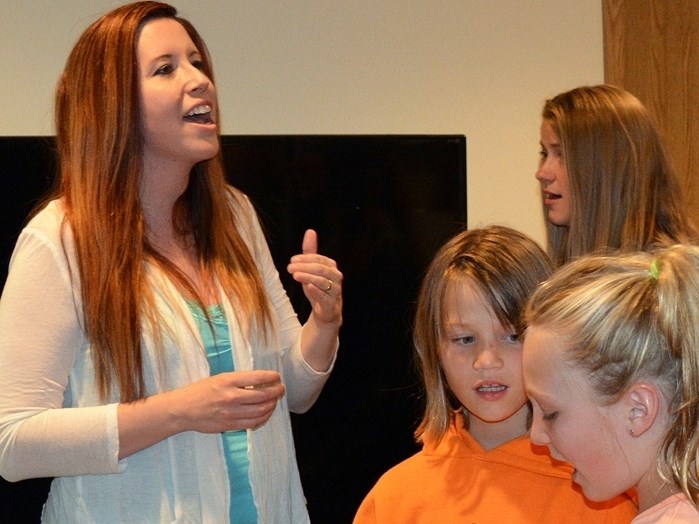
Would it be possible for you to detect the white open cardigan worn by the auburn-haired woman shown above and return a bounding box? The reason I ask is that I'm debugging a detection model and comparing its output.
[0,195,336,524]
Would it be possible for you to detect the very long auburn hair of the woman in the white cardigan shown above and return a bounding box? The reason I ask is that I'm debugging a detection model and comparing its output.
[50,1,271,402]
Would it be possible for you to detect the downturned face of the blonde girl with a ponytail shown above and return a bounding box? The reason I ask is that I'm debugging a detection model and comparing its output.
[522,326,637,501]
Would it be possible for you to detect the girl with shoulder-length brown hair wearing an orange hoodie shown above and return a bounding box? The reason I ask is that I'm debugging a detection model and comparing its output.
[354,226,636,524]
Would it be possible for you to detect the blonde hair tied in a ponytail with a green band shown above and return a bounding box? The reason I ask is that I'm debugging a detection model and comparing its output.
[523,244,699,504]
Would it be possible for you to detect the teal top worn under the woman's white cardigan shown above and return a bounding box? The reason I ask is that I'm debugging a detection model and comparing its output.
[187,301,257,524]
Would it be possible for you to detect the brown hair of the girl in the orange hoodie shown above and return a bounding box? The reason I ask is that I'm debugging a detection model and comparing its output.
[413,225,553,441]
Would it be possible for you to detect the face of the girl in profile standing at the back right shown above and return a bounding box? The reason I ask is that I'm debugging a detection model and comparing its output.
[536,119,570,226]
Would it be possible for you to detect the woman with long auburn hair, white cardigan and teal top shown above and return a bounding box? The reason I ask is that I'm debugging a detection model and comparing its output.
[0,2,342,523]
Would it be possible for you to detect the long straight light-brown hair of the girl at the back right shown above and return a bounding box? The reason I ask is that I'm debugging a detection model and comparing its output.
[542,85,697,266]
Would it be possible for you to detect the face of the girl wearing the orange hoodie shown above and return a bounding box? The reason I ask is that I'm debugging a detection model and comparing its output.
[441,278,529,447]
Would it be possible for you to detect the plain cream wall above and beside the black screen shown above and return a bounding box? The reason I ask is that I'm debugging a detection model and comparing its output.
[0,0,603,247]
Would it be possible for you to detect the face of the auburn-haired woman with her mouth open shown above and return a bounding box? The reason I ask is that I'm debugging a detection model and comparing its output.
[138,18,219,172]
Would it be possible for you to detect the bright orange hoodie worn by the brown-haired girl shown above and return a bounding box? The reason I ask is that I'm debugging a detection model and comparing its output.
[354,417,638,524]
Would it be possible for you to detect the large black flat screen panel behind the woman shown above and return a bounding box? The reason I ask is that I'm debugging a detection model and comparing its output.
[0,135,466,524]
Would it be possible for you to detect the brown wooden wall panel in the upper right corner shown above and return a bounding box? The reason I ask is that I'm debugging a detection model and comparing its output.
[602,0,699,228]
